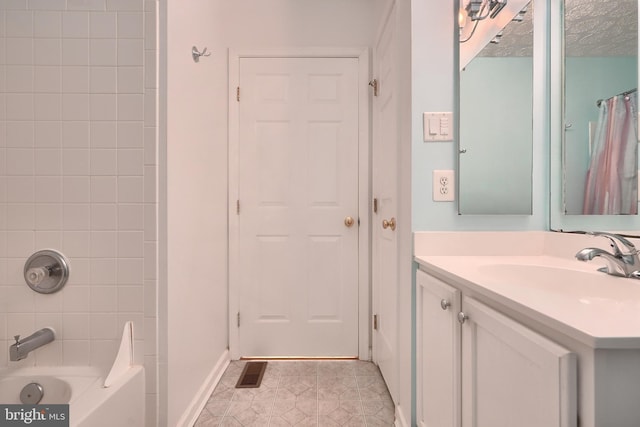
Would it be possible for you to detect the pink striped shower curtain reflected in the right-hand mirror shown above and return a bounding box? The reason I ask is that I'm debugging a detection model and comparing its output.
[583,92,638,215]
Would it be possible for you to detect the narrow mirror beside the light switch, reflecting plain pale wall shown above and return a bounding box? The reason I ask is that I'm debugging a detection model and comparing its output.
[458,0,533,215]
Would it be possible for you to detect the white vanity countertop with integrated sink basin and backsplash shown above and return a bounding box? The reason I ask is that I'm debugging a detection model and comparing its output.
[415,233,640,349]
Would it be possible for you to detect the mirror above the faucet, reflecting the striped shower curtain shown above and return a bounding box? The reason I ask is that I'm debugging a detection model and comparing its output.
[561,0,638,214]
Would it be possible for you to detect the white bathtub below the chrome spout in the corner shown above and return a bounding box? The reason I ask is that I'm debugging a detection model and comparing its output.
[0,366,145,427]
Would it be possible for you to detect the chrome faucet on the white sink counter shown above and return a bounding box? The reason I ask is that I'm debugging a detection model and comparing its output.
[576,231,640,279]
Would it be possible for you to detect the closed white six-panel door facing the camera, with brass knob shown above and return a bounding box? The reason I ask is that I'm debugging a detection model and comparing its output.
[238,58,358,357]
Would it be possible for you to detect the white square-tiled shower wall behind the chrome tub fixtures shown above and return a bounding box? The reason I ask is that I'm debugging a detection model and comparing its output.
[0,0,158,426]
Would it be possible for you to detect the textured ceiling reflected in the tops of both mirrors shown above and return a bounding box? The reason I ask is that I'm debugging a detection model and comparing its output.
[479,0,638,56]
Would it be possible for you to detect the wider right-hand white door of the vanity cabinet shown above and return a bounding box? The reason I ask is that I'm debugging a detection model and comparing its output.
[458,297,577,427]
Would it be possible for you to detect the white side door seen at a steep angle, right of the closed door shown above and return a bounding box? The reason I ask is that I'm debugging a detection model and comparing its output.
[372,4,399,399]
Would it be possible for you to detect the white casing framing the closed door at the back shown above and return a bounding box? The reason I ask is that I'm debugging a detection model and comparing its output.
[227,47,371,360]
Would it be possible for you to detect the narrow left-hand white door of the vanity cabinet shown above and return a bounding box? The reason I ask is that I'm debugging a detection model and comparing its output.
[416,271,461,427]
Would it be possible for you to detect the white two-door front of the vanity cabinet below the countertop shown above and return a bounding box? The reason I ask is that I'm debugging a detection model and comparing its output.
[416,271,578,427]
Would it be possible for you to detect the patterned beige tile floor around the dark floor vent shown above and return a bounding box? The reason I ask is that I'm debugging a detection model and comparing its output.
[195,360,394,427]
